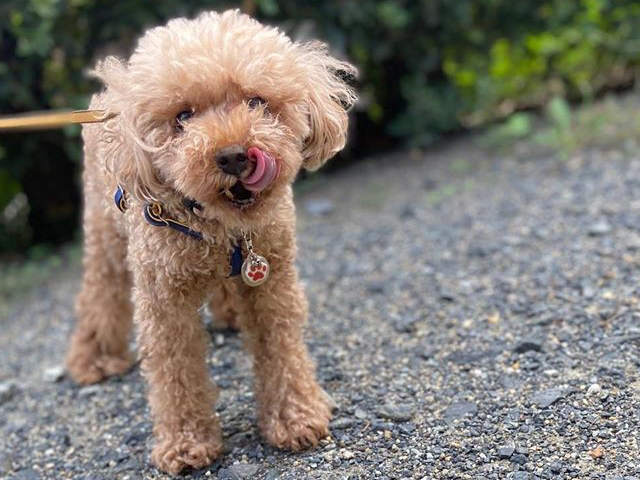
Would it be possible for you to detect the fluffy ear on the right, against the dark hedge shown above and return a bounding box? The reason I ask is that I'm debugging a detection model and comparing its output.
[301,42,357,170]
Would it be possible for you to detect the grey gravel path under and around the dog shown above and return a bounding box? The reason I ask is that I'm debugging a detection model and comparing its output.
[0,130,640,480]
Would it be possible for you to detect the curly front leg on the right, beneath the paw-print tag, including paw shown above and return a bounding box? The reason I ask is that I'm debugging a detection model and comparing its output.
[240,238,331,450]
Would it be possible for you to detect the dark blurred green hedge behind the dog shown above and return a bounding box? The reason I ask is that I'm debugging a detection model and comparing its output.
[0,0,640,262]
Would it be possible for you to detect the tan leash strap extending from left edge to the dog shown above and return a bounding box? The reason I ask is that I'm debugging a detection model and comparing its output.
[0,110,114,132]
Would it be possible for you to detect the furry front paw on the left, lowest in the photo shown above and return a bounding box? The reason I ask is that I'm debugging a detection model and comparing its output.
[151,433,222,475]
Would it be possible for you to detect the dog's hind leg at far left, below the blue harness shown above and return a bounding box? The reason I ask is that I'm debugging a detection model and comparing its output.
[66,132,133,385]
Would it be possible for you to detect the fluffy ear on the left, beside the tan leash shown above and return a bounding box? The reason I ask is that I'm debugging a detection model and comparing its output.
[92,57,166,201]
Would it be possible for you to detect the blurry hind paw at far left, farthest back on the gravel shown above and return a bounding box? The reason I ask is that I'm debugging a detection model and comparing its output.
[67,349,133,385]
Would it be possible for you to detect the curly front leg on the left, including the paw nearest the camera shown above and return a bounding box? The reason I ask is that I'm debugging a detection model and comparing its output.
[134,268,222,474]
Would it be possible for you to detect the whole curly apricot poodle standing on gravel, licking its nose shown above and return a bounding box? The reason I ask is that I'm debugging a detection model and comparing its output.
[66,10,357,474]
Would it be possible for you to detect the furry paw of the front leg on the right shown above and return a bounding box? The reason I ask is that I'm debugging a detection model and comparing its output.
[261,391,331,451]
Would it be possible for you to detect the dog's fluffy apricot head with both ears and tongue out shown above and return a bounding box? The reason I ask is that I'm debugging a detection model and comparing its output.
[97,11,355,226]
